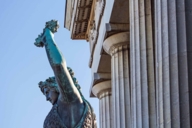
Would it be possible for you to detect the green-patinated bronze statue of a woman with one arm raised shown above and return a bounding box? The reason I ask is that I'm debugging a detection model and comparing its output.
[34,20,96,128]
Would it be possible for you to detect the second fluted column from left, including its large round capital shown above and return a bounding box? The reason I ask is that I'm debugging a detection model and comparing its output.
[103,32,131,128]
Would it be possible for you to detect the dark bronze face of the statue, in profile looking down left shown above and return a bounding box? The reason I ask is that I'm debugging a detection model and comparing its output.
[43,88,59,105]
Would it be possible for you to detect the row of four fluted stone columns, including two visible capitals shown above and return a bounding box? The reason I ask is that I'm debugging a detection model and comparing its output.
[92,0,192,128]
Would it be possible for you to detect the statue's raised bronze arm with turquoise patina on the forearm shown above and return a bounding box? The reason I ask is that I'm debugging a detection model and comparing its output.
[43,28,83,103]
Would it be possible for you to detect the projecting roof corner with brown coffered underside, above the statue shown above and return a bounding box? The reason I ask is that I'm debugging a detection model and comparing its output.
[64,0,93,39]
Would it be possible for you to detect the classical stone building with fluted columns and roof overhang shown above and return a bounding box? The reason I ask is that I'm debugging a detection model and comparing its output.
[64,0,192,128]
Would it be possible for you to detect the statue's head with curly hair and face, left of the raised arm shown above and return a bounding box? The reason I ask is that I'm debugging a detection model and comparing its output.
[39,77,59,105]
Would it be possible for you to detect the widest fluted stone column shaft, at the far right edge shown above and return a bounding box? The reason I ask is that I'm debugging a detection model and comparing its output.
[154,0,192,128]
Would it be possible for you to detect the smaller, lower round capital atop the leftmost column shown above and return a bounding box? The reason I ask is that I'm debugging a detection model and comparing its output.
[92,80,111,99]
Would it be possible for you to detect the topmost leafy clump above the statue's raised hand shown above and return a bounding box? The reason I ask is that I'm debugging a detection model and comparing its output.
[45,20,59,33]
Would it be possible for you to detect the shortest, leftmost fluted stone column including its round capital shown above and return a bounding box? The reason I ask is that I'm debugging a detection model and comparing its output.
[92,80,112,128]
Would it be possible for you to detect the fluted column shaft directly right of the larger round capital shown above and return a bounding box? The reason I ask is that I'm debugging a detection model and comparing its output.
[129,0,156,128]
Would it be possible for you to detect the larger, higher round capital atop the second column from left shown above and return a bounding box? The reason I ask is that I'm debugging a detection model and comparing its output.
[103,32,129,55]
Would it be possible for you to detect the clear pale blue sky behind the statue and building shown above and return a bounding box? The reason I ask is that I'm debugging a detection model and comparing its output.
[0,0,99,128]
